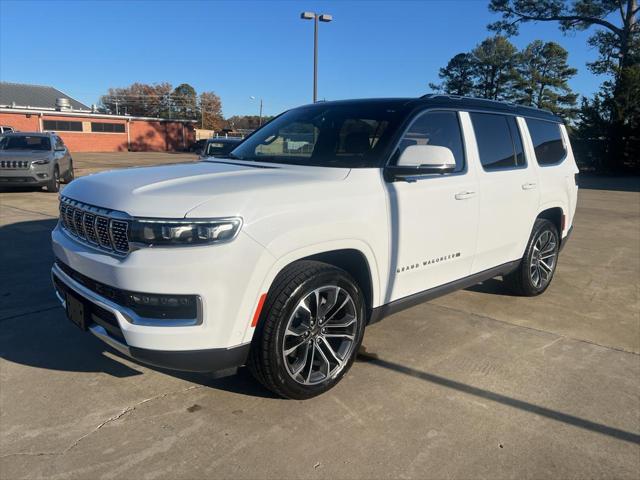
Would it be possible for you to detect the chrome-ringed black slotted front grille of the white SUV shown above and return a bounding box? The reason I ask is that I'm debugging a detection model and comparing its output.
[60,197,129,255]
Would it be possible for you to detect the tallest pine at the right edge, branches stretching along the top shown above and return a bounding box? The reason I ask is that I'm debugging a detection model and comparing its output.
[489,0,640,171]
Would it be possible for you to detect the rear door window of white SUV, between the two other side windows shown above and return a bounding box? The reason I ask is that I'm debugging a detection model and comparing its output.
[470,113,526,171]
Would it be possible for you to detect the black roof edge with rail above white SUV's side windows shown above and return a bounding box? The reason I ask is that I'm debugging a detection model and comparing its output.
[298,94,563,123]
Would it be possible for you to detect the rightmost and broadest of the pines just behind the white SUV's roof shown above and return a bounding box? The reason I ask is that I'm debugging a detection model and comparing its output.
[514,40,578,118]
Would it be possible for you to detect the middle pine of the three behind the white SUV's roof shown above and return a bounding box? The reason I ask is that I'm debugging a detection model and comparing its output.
[471,35,517,100]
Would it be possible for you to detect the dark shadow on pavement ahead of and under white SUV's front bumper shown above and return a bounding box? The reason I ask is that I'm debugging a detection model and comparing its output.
[0,219,273,397]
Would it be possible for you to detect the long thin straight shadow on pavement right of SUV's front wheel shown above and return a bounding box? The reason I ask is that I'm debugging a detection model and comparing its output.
[357,346,640,444]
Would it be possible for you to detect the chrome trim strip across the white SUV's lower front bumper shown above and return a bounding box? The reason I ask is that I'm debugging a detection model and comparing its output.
[51,263,203,326]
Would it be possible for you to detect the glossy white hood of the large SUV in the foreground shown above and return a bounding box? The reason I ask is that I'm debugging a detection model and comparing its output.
[62,160,349,218]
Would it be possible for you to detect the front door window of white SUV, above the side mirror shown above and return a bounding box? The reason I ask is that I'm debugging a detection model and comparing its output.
[396,112,465,172]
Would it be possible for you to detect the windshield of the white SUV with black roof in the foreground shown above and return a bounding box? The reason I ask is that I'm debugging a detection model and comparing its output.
[231,102,402,168]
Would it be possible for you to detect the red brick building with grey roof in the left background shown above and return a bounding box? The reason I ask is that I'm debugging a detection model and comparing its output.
[0,82,195,152]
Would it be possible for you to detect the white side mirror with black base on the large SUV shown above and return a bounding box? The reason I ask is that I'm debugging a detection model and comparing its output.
[385,145,456,182]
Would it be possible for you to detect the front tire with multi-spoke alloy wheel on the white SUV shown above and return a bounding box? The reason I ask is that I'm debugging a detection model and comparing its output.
[248,260,365,400]
